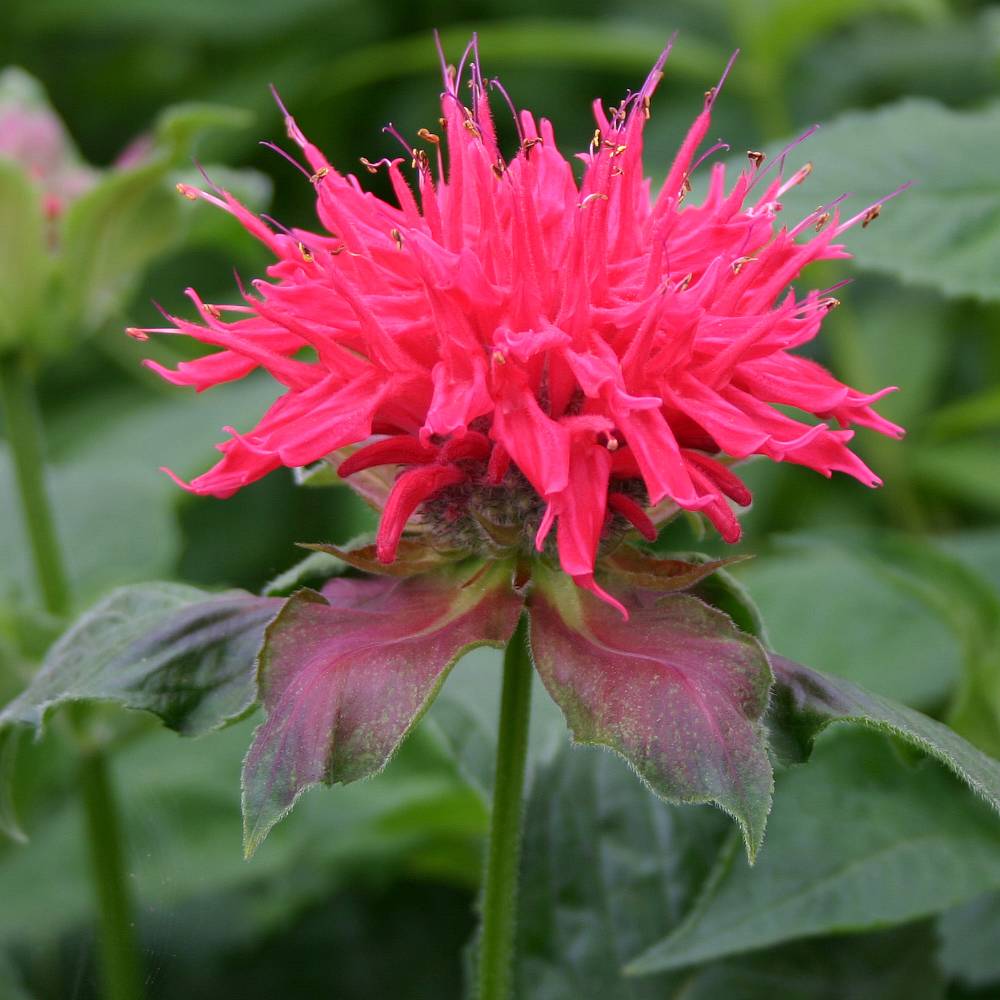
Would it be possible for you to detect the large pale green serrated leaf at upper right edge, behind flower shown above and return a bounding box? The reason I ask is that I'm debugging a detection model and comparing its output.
[782,98,1000,301]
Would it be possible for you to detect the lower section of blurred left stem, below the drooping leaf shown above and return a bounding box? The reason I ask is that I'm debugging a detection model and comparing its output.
[80,748,142,1000]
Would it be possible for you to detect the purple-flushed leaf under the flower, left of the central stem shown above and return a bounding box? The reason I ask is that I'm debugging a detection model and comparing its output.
[243,563,521,855]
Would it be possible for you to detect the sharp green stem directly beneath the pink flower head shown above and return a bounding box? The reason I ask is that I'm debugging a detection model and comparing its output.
[479,616,532,1000]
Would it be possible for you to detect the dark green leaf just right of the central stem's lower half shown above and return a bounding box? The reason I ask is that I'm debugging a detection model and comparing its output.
[514,742,735,1000]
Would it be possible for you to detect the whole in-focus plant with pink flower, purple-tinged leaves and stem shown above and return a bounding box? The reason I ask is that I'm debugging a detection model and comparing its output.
[3,33,1000,1000]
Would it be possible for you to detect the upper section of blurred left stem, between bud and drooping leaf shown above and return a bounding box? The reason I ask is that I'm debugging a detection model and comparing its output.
[0,354,69,617]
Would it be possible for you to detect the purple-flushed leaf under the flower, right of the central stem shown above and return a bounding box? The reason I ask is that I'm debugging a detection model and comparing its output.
[529,568,772,858]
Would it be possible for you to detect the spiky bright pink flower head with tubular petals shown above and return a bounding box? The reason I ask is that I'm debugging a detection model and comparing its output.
[139,42,902,608]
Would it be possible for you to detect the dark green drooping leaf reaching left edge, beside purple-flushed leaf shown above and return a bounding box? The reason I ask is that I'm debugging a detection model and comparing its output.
[0,583,281,736]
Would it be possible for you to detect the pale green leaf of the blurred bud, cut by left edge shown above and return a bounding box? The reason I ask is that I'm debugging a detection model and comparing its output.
[0,157,49,349]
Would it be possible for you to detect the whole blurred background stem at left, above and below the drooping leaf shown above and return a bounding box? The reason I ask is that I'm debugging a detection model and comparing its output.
[0,352,142,1000]
